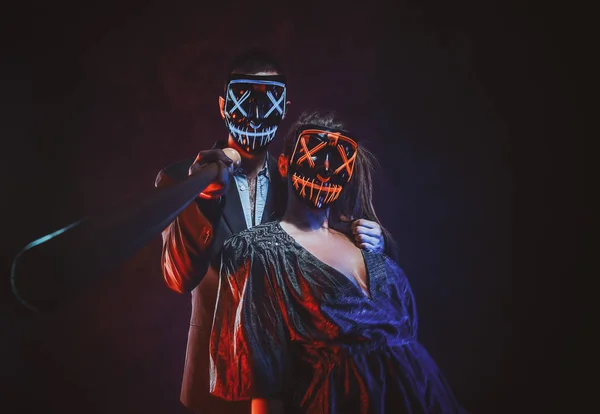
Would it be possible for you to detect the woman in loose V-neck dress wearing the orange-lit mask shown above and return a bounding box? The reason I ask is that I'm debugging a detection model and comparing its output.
[210,113,462,414]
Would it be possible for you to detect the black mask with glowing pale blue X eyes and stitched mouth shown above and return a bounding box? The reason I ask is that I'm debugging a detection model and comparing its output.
[224,74,286,153]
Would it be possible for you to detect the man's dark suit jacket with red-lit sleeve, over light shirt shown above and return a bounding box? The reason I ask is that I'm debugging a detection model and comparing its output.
[156,150,287,414]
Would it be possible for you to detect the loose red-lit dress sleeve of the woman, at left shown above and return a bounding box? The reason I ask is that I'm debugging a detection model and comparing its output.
[210,235,289,401]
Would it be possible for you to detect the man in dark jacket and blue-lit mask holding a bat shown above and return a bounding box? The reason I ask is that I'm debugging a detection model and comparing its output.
[156,50,384,414]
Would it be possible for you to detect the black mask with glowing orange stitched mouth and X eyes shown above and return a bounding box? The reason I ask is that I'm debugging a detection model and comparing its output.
[288,125,358,208]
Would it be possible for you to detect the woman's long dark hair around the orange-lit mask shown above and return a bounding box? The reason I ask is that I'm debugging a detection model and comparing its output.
[283,110,398,260]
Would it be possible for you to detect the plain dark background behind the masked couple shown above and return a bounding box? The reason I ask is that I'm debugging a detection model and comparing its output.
[0,1,577,414]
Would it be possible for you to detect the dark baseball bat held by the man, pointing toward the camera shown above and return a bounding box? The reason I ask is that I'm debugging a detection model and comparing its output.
[10,148,240,312]
